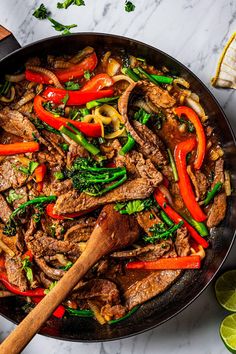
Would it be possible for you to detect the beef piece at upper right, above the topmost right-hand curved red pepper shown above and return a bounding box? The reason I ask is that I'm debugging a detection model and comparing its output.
[138,81,176,108]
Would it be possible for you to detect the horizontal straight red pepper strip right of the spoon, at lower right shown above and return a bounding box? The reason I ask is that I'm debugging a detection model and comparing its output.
[126,256,201,270]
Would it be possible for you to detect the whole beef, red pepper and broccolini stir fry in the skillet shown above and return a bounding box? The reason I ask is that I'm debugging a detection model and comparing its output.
[0,47,231,325]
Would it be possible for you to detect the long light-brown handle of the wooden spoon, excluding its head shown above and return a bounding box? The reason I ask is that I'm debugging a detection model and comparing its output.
[0,252,97,354]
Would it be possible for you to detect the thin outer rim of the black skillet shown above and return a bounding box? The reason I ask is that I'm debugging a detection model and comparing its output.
[0,32,236,343]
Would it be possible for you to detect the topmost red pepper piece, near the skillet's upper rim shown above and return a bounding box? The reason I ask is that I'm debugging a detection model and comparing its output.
[55,53,98,82]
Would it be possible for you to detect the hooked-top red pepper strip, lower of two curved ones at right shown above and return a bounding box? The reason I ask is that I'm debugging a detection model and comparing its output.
[174,138,207,222]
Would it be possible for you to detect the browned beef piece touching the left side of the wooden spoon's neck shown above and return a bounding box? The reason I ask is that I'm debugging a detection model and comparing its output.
[25,231,81,258]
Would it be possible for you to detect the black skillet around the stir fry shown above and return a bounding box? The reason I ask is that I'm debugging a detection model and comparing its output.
[0,27,236,342]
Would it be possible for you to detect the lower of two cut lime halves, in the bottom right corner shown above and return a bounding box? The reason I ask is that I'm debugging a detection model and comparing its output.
[220,313,236,354]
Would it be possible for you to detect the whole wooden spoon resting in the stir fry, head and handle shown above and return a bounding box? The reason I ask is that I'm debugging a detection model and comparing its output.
[0,205,139,354]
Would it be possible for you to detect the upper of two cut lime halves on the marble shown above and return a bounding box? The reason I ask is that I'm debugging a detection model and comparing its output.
[215,270,236,312]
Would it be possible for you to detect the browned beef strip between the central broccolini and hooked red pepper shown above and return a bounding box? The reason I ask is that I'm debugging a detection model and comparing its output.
[133,121,168,166]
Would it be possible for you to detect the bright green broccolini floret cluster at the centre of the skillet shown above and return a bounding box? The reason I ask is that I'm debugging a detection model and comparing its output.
[68,158,127,196]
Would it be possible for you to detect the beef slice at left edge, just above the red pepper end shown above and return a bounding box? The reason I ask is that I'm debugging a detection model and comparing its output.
[0,107,39,141]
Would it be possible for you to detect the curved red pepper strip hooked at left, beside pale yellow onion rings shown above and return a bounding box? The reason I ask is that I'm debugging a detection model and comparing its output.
[34,96,101,138]
